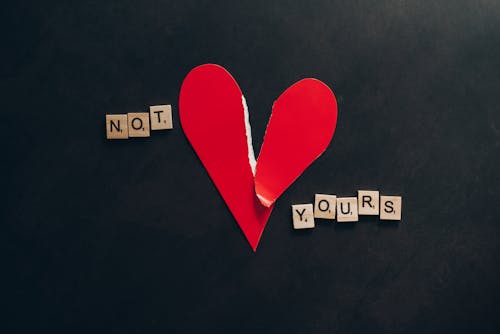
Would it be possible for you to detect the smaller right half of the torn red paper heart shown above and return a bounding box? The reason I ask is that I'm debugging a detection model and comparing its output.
[255,79,337,206]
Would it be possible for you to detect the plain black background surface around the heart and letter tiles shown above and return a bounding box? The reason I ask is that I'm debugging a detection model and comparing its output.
[0,0,500,333]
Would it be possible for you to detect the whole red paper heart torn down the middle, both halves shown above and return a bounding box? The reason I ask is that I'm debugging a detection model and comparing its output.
[179,64,337,251]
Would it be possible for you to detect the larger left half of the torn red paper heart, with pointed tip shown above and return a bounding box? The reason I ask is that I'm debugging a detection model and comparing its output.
[179,64,272,251]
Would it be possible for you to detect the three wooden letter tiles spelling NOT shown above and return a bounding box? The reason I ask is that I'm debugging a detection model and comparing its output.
[106,104,173,139]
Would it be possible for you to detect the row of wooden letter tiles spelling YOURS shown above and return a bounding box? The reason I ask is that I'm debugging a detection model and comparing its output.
[292,190,402,229]
